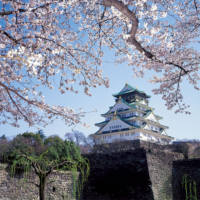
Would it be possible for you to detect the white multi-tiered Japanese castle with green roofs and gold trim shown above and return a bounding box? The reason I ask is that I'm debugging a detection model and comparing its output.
[91,83,174,144]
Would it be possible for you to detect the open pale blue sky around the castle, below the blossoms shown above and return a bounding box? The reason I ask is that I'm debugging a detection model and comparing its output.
[0,45,200,142]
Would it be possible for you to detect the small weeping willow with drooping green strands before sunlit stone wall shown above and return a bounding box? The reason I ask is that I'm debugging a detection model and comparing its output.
[11,149,89,200]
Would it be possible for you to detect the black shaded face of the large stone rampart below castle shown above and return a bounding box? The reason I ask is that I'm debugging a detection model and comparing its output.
[82,148,154,200]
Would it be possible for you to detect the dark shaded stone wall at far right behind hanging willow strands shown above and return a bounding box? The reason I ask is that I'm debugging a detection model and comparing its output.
[172,159,200,200]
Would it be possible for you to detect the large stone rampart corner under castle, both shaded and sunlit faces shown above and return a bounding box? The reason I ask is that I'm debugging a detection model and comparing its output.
[83,148,183,200]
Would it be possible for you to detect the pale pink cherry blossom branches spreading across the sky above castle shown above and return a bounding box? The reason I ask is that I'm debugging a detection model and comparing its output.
[0,0,200,127]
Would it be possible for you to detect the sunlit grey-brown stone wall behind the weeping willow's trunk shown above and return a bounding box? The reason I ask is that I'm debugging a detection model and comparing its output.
[0,163,79,200]
